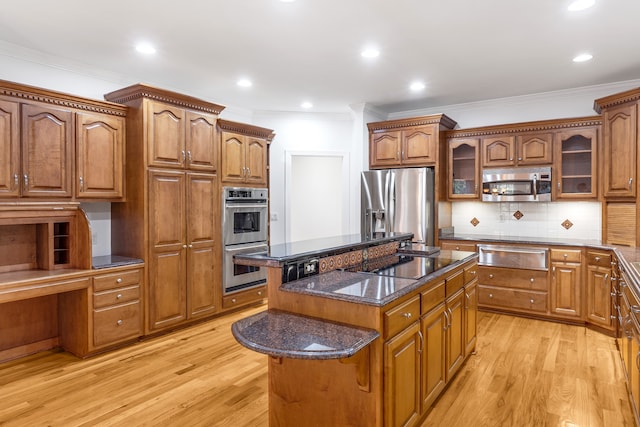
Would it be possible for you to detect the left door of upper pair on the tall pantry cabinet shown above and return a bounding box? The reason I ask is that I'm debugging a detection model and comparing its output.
[147,102,187,168]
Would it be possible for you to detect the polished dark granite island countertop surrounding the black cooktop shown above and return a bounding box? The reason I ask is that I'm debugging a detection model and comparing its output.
[280,250,478,306]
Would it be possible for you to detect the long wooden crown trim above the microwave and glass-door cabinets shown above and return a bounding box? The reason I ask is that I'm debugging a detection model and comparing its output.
[446,116,602,139]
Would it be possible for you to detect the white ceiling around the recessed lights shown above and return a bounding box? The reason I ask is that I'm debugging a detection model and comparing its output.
[0,0,640,112]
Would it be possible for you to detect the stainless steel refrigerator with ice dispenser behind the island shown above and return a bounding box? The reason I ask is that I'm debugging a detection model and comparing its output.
[360,168,435,246]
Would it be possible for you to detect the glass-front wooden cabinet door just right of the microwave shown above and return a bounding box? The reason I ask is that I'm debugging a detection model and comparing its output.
[555,128,597,198]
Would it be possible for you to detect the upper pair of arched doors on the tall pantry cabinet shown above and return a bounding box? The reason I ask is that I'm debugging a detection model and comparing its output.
[147,101,217,171]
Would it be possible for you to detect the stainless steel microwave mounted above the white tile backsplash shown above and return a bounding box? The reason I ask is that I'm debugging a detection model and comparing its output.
[482,167,551,202]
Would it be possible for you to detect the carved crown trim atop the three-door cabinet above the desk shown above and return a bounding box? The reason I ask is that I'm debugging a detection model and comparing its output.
[0,80,127,117]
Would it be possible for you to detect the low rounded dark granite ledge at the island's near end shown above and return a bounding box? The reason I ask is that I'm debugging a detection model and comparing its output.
[231,310,380,360]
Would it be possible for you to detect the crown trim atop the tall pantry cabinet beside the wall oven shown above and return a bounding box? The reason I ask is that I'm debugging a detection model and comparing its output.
[104,83,225,115]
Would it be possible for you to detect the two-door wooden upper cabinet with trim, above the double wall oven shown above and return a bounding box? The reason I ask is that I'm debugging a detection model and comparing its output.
[218,120,274,187]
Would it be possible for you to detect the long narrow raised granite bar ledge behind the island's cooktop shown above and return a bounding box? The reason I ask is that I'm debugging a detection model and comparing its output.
[233,233,413,267]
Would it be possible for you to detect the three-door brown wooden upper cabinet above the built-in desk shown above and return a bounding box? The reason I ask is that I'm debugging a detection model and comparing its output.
[0,81,126,201]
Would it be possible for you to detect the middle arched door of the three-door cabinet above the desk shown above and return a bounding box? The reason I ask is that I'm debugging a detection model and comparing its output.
[22,105,73,197]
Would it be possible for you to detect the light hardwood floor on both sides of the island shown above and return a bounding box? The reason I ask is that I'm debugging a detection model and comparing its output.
[0,306,634,427]
